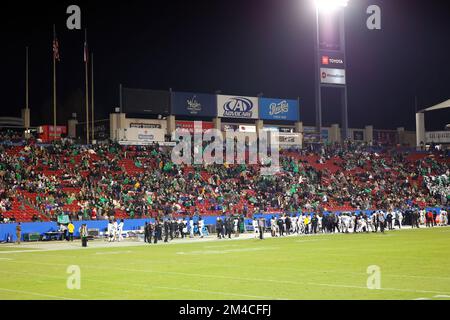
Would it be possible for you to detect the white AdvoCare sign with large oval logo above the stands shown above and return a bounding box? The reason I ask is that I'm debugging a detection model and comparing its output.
[217,95,259,119]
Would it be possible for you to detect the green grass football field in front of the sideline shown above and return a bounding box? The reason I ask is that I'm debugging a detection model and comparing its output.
[0,228,450,300]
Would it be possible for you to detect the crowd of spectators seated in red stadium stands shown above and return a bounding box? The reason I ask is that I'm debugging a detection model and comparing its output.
[0,131,450,221]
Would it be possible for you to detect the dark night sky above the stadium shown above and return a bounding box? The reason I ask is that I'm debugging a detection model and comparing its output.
[0,0,450,130]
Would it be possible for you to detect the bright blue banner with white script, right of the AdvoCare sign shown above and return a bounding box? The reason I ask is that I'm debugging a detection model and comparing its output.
[259,98,300,121]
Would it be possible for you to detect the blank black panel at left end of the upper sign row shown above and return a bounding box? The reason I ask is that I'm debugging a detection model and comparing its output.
[122,88,170,115]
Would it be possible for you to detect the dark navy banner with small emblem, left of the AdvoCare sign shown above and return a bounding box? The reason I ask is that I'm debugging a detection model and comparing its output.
[171,92,217,117]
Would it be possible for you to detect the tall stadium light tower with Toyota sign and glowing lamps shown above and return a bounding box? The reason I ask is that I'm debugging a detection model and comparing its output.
[314,0,349,141]
